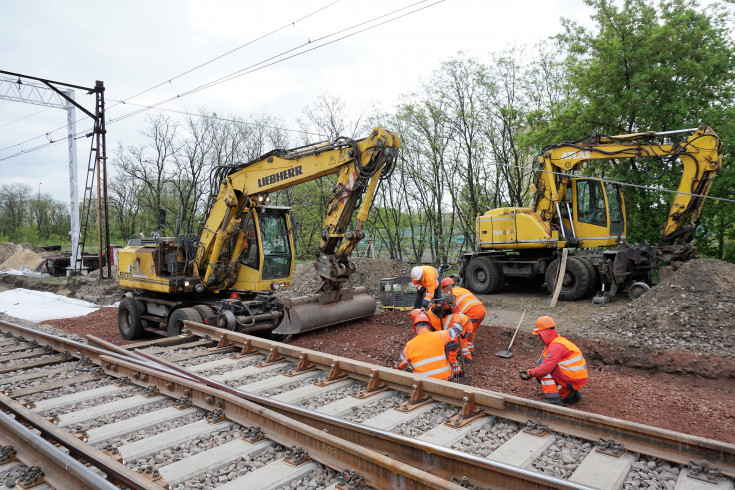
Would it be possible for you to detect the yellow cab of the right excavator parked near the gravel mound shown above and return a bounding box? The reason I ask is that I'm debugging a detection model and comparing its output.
[560,178,626,248]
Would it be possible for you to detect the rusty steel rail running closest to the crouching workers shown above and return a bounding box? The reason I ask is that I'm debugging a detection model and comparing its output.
[171,321,735,478]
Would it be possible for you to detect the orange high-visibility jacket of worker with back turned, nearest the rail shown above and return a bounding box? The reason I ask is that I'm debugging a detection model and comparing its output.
[398,330,452,380]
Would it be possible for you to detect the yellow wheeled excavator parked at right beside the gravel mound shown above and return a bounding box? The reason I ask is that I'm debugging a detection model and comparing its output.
[460,126,722,305]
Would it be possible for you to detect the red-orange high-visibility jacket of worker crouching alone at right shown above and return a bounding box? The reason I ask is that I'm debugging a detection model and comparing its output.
[528,335,587,388]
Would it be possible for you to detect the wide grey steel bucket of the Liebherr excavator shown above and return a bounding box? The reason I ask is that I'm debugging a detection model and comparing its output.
[273,286,376,335]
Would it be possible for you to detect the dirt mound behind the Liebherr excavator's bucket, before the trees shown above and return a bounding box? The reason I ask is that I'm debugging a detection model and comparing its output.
[285,257,411,299]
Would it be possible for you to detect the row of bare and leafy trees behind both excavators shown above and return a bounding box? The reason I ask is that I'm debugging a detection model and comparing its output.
[0,0,735,263]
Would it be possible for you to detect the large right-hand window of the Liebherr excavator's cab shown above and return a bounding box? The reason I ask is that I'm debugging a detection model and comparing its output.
[258,212,292,279]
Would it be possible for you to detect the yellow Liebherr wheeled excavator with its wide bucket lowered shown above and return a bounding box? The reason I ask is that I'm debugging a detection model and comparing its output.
[118,128,401,340]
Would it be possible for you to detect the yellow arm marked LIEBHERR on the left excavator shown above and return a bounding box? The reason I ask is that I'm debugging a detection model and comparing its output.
[192,128,401,291]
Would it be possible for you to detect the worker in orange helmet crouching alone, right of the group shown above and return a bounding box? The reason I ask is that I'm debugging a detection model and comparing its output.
[520,316,587,406]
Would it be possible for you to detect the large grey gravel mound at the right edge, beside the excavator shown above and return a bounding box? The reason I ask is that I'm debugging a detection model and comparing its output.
[601,259,735,355]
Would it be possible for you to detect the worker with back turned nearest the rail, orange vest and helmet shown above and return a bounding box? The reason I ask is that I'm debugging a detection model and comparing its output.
[393,309,460,380]
